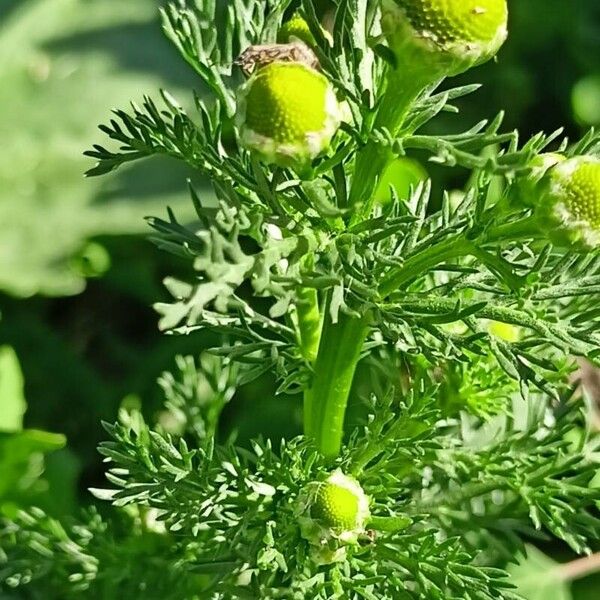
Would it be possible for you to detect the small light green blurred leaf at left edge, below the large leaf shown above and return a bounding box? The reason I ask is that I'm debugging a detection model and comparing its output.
[0,346,27,432]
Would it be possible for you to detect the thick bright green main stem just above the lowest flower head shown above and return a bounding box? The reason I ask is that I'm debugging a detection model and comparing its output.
[304,315,369,459]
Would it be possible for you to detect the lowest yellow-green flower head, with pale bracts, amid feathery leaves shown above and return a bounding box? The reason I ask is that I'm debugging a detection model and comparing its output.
[298,470,370,564]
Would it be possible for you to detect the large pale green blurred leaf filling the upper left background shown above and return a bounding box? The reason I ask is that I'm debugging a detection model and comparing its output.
[0,0,204,296]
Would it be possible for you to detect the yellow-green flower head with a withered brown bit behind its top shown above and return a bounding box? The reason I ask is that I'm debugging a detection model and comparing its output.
[237,62,342,169]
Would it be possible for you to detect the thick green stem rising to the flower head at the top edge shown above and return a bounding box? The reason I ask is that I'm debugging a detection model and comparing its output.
[349,68,431,221]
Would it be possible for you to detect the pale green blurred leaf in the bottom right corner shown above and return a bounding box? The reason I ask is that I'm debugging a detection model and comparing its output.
[508,546,573,600]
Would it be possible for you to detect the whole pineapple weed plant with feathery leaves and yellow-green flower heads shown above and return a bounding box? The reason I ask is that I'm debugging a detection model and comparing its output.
[0,0,600,600]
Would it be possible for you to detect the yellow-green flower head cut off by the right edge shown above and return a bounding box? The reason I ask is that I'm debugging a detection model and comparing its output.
[536,156,600,250]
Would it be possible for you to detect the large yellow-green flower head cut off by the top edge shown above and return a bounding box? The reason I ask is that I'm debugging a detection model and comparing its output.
[382,0,508,76]
